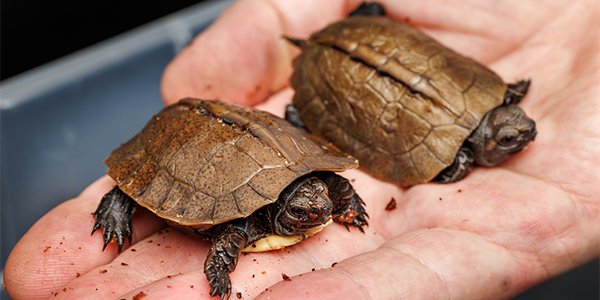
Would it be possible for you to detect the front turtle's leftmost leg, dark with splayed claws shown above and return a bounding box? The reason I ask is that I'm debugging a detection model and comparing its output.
[92,187,136,252]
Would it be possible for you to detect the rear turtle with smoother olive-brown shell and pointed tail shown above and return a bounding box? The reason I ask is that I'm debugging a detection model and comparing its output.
[286,3,537,187]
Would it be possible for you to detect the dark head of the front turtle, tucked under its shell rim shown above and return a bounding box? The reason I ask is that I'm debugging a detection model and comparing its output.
[274,177,333,235]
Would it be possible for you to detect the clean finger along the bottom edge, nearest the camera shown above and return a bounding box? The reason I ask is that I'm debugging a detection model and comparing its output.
[257,228,544,299]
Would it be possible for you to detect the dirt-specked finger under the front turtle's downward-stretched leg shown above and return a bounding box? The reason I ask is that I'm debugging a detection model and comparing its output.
[49,211,383,299]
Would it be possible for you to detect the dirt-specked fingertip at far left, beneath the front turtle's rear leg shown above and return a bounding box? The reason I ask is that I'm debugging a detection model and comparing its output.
[4,177,164,299]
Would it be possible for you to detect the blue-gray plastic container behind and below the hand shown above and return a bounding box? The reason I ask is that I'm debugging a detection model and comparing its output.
[0,0,598,299]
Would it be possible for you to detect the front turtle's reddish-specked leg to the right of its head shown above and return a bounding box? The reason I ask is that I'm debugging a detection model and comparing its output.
[319,172,369,232]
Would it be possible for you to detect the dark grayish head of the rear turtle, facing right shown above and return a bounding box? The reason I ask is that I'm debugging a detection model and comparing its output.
[469,105,537,166]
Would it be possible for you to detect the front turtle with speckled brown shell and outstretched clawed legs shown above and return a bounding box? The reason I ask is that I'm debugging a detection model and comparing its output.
[92,98,368,299]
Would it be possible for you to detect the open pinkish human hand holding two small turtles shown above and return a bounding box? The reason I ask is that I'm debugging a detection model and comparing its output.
[4,0,600,299]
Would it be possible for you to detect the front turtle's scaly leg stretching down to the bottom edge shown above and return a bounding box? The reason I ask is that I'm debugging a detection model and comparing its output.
[204,221,249,299]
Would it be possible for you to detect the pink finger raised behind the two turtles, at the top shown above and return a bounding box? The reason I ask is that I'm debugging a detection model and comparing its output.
[162,0,358,105]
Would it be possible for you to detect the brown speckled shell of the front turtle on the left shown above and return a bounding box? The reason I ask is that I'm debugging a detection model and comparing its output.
[106,99,358,229]
